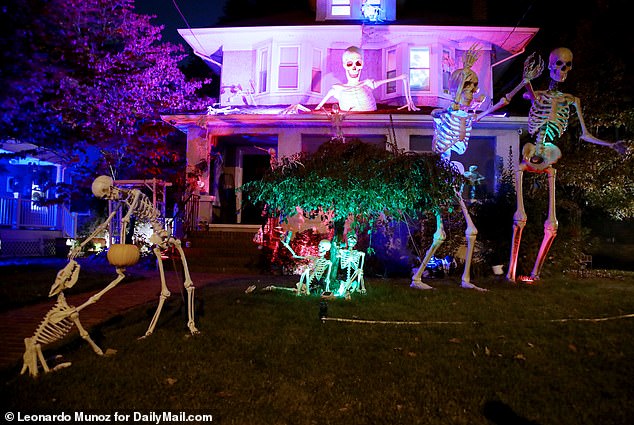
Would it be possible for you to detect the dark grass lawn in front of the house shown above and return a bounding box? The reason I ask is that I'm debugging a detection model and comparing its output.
[0,266,634,425]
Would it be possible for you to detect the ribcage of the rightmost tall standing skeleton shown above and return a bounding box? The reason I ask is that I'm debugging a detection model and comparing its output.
[528,92,570,143]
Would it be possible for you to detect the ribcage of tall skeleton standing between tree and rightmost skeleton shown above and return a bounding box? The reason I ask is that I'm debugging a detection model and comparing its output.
[432,110,472,155]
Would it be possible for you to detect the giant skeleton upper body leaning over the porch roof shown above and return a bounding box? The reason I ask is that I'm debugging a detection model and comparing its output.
[283,46,419,113]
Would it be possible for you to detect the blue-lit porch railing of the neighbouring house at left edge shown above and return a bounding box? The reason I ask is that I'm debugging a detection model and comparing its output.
[0,196,77,238]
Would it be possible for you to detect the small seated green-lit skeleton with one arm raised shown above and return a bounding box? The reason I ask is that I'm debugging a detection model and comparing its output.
[276,232,332,295]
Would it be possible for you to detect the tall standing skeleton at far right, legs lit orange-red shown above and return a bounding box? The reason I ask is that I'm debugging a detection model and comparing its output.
[500,47,624,282]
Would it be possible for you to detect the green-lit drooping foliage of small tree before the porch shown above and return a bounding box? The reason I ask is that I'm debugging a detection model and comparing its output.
[241,140,462,229]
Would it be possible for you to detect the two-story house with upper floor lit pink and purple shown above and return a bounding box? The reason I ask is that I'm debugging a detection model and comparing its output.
[163,0,538,229]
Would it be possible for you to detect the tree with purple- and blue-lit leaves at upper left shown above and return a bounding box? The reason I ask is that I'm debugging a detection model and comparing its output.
[0,0,209,186]
